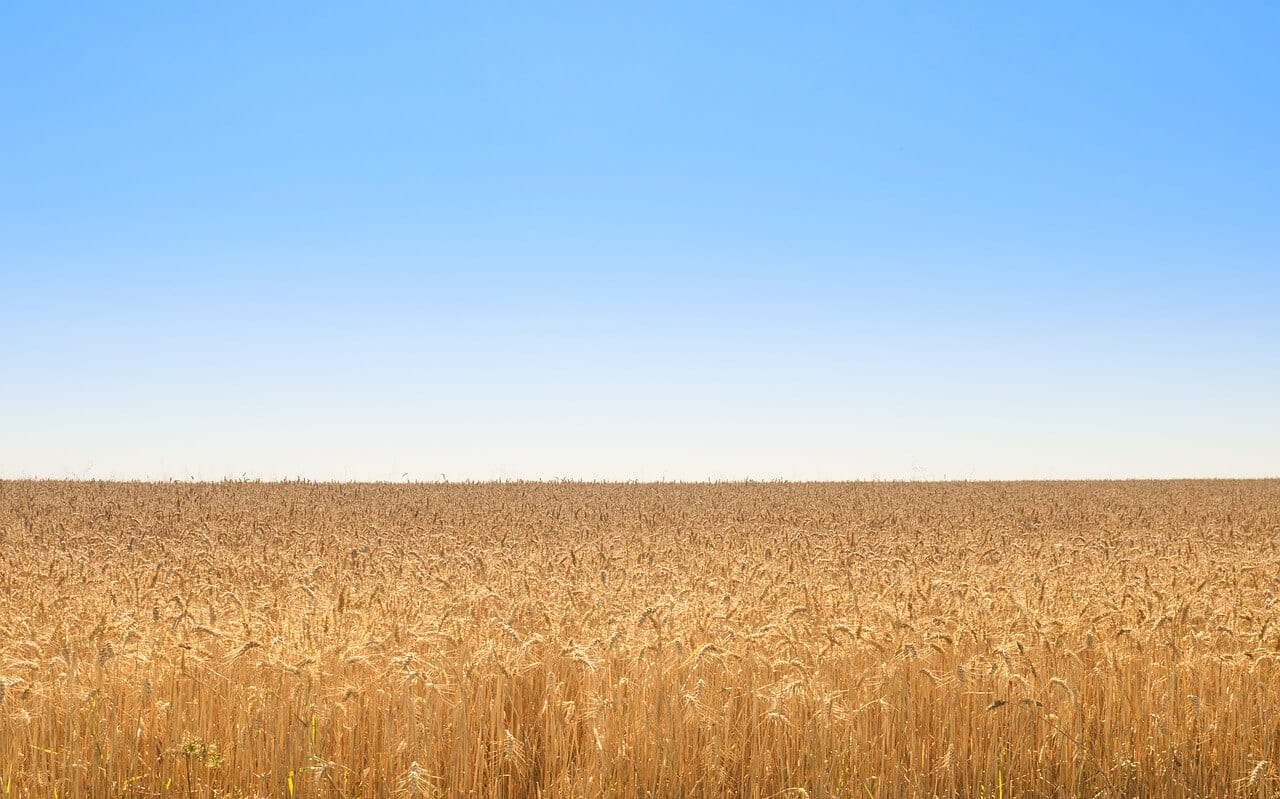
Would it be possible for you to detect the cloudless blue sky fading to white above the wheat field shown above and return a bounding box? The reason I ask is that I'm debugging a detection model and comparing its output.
[0,1,1280,480]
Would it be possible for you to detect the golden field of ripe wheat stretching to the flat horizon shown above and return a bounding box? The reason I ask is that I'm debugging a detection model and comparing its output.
[0,481,1280,799]
